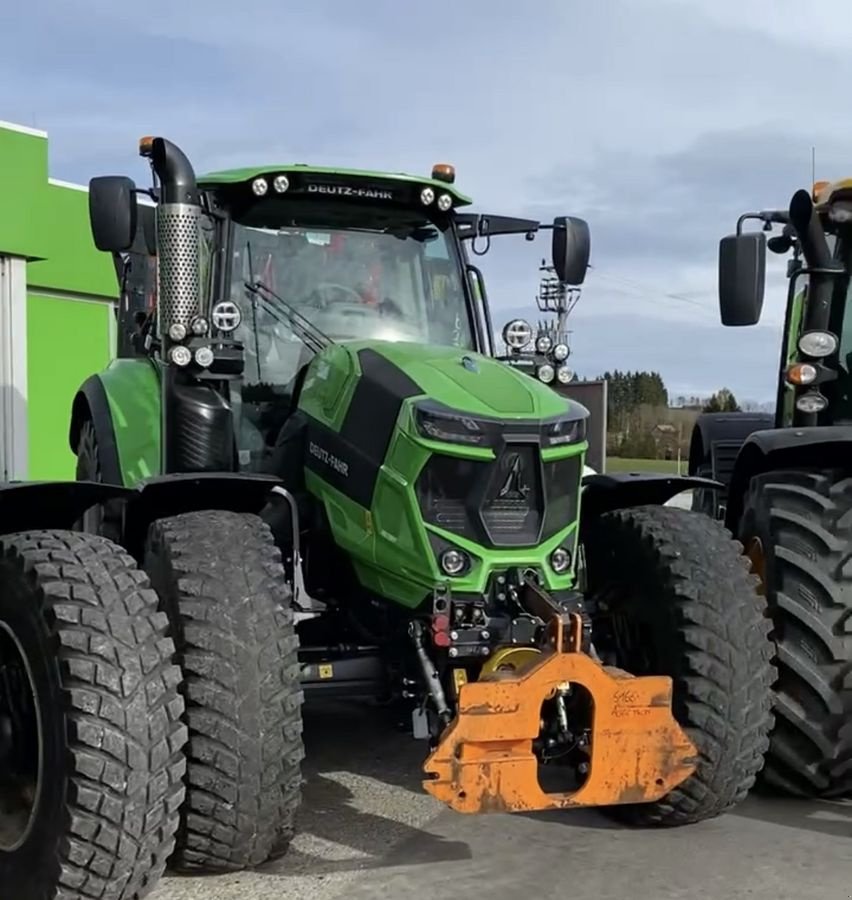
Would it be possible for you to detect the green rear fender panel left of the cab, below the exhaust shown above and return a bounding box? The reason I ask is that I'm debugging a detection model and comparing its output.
[97,359,161,487]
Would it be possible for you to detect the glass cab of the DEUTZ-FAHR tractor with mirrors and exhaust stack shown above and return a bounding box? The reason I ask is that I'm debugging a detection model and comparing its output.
[90,138,590,471]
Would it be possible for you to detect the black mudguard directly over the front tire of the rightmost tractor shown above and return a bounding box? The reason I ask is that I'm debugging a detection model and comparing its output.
[725,425,852,534]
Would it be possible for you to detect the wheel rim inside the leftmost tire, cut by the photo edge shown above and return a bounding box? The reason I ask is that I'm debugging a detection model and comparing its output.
[0,621,44,853]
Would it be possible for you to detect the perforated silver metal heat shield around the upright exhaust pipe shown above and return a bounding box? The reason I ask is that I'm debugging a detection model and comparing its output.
[157,203,202,334]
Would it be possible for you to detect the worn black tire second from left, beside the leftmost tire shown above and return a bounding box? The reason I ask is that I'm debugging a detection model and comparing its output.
[144,510,304,872]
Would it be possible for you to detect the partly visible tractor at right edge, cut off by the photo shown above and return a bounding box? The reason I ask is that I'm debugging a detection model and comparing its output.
[689,180,852,798]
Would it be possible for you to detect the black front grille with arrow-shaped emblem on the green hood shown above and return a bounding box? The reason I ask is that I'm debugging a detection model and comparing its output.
[417,444,580,547]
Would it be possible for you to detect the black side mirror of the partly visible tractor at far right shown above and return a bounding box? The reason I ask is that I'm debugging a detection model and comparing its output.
[719,231,766,326]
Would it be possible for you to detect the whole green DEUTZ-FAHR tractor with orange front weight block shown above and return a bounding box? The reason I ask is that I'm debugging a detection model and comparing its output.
[0,138,773,900]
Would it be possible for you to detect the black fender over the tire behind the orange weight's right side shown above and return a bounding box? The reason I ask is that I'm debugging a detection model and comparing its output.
[582,472,724,520]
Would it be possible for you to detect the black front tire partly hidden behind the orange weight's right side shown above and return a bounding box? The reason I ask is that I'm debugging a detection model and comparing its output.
[585,506,775,825]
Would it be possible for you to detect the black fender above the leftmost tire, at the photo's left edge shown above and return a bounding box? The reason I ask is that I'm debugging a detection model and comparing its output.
[0,481,135,534]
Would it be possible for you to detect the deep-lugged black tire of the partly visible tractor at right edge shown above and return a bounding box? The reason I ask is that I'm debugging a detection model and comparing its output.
[738,470,852,798]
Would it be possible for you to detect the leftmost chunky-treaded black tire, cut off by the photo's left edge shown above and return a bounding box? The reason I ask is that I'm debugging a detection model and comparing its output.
[0,531,186,900]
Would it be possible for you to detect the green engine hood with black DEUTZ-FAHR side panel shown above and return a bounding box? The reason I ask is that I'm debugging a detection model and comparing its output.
[298,341,587,607]
